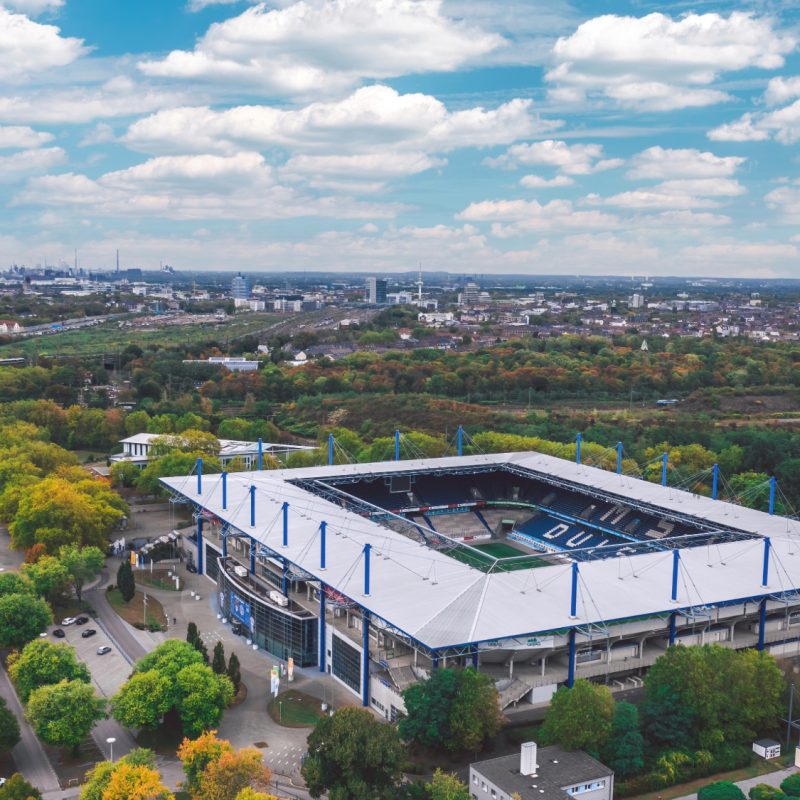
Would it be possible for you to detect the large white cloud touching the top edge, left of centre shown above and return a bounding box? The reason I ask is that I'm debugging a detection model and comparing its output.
[140,0,503,96]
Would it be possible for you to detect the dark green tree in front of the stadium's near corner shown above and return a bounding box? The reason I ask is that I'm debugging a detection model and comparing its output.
[398,668,502,751]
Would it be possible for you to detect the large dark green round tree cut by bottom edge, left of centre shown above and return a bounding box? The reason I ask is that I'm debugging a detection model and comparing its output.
[301,708,404,800]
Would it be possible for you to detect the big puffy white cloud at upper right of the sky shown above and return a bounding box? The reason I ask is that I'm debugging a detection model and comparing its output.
[546,12,796,111]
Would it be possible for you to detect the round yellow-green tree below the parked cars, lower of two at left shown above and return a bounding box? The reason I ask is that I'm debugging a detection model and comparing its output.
[28,681,106,754]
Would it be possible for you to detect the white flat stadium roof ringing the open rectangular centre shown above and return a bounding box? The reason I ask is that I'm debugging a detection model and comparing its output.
[162,453,800,649]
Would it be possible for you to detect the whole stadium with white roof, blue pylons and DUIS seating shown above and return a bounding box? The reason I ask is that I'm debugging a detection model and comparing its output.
[163,452,800,719]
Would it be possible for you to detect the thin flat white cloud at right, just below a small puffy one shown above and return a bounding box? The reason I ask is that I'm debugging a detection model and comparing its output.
[587,178,746,209]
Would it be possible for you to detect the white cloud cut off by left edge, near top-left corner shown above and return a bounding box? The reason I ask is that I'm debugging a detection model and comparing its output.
[0,6,87,82]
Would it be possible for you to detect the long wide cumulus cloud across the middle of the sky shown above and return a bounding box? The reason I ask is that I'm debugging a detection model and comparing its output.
[123,85,542,191]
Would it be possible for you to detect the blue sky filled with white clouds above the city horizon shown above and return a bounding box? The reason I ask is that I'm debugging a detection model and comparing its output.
[0,0,800,278]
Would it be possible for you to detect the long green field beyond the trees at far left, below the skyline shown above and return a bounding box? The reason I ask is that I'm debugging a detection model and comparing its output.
[0,314,286,358]
